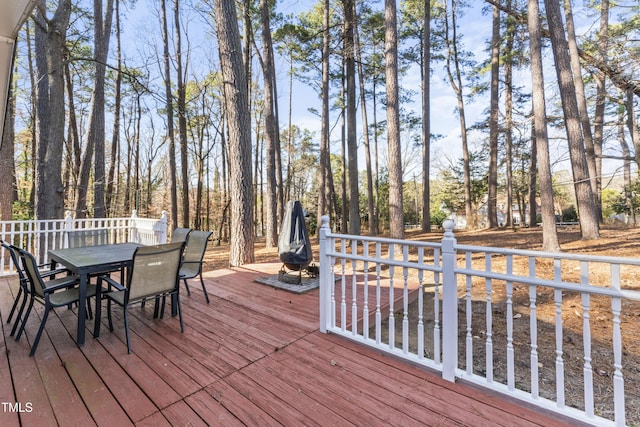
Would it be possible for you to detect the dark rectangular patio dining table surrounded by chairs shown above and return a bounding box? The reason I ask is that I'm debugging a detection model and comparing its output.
[49,243,141,346]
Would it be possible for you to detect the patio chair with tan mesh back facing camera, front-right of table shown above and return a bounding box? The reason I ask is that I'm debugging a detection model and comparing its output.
[98,242,184,353]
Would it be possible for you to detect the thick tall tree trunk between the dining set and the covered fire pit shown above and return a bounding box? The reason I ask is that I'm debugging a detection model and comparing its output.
[214,0,255,266]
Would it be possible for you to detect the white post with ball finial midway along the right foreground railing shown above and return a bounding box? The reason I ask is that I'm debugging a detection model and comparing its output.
[442,220,458,382]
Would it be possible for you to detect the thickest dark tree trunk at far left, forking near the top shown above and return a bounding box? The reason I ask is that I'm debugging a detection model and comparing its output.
[34,0,71,220]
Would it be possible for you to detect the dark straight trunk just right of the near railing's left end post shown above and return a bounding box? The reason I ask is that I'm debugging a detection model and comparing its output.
[343,0,360,235]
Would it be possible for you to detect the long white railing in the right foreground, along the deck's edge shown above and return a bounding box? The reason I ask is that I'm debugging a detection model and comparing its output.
[319,217,640,426]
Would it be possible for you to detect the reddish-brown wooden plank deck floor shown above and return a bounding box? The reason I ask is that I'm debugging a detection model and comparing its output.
[0,264,588,427]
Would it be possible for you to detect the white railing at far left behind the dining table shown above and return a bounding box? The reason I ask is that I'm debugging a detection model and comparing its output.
[0,210,167,276]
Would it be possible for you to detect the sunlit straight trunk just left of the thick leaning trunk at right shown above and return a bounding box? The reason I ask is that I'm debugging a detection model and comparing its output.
[527,0,560,252]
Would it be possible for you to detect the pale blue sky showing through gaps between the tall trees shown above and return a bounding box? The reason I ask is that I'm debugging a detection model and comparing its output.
[114,0,624,183]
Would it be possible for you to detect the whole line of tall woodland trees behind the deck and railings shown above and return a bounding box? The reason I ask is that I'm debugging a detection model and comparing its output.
[0,0,640,265]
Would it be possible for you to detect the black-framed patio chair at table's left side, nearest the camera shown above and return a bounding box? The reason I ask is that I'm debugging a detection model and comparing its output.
[16,249,100,356]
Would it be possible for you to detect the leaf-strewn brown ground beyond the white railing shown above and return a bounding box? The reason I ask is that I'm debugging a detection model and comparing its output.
[206,227,640,426]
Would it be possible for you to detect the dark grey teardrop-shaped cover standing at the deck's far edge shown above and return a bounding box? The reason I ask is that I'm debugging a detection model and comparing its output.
[278,200,313,271]
